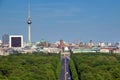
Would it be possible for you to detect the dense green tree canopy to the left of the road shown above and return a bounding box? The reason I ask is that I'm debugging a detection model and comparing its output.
[0,53,61,80]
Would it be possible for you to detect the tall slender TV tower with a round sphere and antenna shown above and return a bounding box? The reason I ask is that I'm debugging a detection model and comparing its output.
[27,0,32,43]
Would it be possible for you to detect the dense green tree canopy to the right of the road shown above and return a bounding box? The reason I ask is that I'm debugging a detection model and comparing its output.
[72,53,120,80]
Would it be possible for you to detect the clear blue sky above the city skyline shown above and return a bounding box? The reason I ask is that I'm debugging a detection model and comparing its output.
[0,0,120,42]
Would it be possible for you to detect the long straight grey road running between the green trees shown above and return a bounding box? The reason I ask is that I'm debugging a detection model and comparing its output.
[60,52,72,80]
